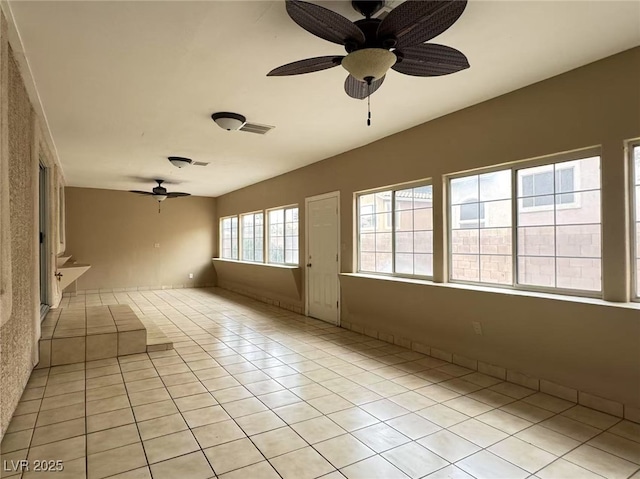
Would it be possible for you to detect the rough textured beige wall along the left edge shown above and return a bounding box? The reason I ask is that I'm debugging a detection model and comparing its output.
[0,16,63,438]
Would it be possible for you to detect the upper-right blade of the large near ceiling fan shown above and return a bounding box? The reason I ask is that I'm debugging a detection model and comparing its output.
[378,0,467,49]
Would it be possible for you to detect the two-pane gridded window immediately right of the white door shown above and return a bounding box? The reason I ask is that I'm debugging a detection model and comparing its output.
[358,184,433,277]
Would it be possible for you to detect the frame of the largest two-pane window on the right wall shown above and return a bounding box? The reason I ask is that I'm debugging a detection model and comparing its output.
[445,148,603,298]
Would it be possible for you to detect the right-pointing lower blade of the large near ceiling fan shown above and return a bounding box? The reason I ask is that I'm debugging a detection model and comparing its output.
[391,43,469,77]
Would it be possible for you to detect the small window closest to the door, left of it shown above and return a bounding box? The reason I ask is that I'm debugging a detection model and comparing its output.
[268,207,298,264]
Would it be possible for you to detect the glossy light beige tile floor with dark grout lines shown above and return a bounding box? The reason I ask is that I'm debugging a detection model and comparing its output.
[1,289,640,479]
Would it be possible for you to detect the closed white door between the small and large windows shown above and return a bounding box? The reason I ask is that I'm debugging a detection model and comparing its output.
[306,192,340,324]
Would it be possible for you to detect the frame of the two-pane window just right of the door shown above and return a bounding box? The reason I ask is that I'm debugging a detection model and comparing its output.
[354,178,434,281]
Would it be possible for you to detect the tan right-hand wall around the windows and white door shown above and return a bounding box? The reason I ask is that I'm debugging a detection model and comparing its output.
[217,48,640,406]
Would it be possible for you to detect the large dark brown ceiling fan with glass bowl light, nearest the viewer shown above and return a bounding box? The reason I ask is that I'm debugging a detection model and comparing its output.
[267,0,469,100]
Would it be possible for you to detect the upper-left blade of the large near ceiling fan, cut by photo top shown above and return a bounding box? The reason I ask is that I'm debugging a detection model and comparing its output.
[287,0,365,45]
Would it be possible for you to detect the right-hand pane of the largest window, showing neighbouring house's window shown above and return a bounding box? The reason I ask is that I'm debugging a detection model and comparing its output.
[516,157,601,291]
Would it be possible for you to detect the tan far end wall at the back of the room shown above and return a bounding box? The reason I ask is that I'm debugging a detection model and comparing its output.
[66,187,218,290]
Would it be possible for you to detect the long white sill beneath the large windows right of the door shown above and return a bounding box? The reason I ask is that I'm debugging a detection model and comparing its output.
[340,273,640,310]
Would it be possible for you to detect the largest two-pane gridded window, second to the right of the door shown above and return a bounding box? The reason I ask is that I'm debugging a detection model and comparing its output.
[449,156,602,294]
